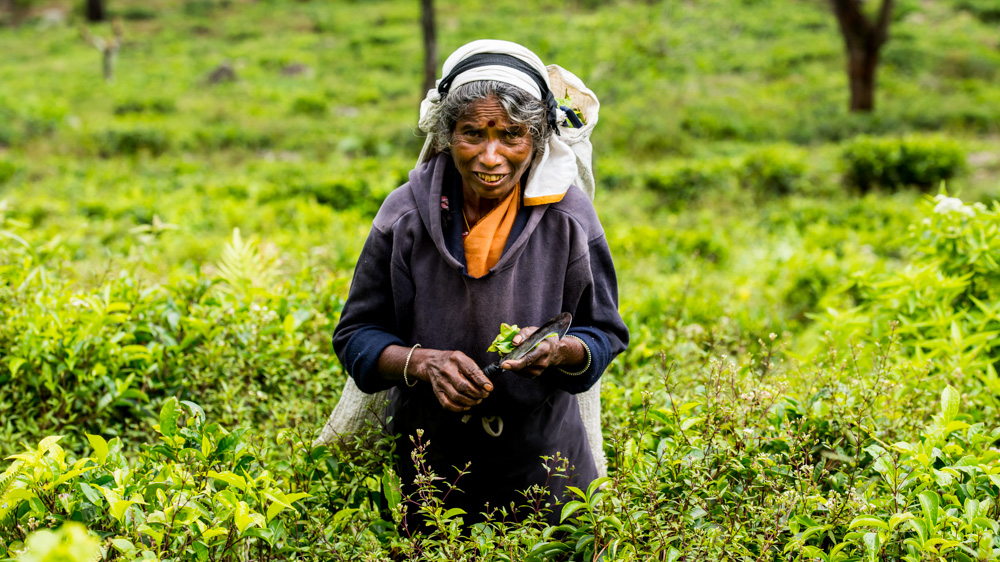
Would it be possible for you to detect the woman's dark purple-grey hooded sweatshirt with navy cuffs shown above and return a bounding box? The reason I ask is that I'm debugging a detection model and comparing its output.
[333,154,628,523]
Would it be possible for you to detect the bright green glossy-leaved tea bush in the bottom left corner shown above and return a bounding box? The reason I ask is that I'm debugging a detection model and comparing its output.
[0,399,309,560]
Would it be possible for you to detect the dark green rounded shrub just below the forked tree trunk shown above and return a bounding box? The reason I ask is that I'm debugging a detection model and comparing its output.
[841,137,965,192]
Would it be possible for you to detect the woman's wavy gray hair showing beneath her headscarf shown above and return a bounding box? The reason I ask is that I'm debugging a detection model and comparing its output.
[432,80,552,156]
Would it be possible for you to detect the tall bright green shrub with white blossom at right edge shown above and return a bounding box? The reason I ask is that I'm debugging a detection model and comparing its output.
[819,195,1000,412]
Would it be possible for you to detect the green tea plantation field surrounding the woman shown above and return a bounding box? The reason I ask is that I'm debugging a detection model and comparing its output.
[0,0,1000,562]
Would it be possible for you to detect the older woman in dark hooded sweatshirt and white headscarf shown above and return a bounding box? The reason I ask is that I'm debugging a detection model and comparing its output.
[333,41,628,523]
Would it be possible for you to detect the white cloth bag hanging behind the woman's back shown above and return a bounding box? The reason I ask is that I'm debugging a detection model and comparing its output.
[313,64,608,476]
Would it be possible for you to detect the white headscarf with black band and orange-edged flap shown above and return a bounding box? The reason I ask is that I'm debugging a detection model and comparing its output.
[417,39,578,206]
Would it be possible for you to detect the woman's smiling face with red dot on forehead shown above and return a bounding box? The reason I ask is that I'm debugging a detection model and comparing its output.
[451,97,534,199]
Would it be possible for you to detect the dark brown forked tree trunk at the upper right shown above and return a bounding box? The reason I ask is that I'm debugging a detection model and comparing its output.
[831,0,895,112]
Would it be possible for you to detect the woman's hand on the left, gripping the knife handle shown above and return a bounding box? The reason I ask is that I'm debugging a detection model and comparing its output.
[410,348,493,412]
